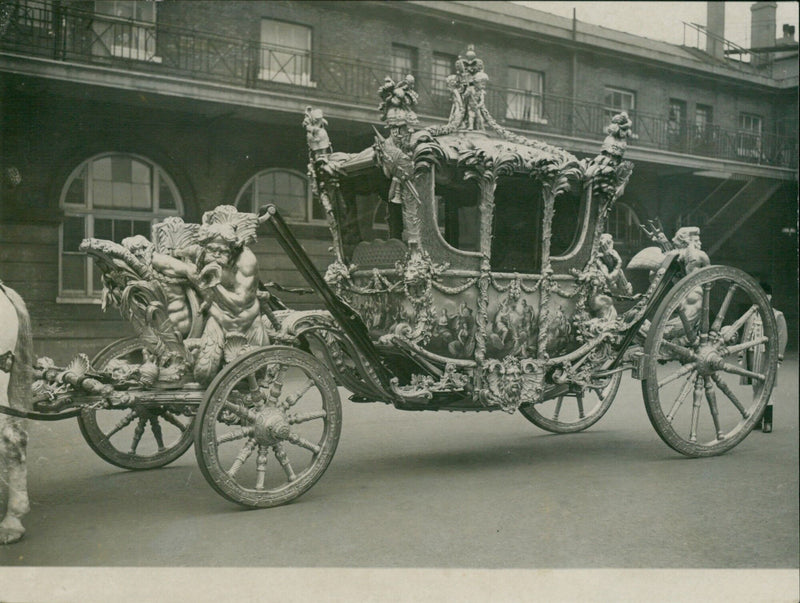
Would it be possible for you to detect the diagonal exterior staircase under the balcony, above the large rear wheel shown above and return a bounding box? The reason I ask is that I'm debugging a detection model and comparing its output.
[679,177,781,255]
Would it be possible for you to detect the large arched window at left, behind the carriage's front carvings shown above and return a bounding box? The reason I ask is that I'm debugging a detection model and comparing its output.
[58,153,183,302]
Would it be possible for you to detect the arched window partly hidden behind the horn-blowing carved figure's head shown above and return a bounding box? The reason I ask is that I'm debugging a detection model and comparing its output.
[236,169,325,222]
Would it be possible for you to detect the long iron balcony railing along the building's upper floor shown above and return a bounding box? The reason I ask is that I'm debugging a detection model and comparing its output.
[0,0,798,168]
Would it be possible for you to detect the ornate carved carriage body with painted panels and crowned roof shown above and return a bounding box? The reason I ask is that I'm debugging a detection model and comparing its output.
[309,52,643,412]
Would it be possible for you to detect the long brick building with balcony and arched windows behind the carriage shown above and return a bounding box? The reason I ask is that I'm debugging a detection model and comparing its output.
[0,0,798,360]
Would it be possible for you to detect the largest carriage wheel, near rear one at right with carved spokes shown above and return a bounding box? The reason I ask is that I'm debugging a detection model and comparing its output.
[642,266,778,457]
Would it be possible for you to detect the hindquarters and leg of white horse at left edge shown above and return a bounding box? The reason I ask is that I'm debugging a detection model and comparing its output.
[0,281,33,544]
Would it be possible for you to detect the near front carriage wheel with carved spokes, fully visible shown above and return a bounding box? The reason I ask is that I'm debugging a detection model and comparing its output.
[195,346,342,507]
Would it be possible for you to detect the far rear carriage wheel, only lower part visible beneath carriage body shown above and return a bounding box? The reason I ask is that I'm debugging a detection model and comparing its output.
[519,373,622,433]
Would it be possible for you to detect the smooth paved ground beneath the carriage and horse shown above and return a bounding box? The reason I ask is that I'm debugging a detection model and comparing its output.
[0,358,799,568]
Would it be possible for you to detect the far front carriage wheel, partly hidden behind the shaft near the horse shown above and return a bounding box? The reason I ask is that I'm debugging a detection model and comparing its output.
[78,337,193,469]
